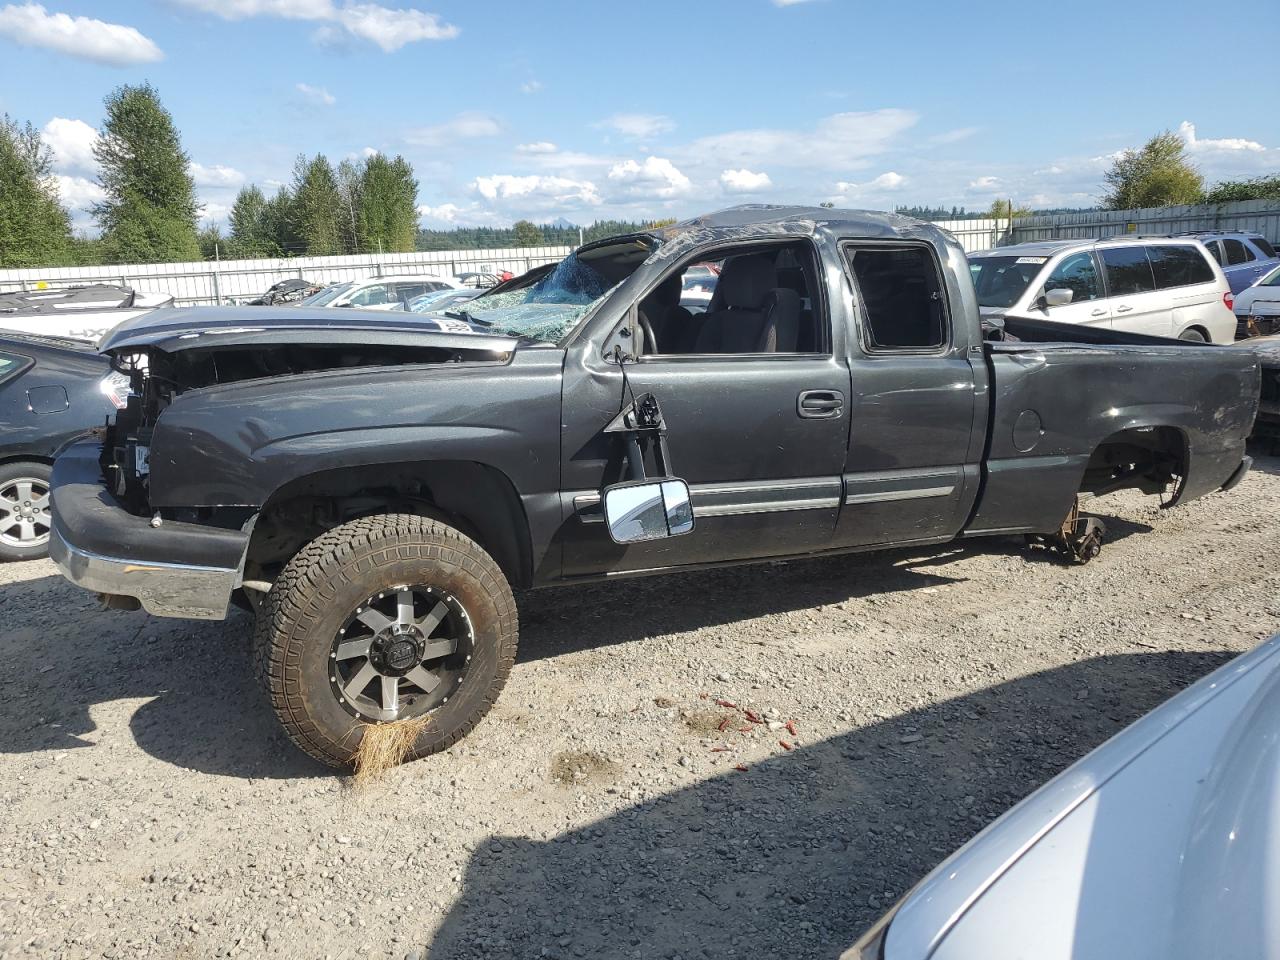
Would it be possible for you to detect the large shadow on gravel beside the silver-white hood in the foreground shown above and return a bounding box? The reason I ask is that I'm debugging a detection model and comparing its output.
[429,652,1233,960]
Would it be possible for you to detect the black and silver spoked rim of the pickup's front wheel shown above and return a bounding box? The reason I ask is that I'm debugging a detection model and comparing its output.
[329,585,475,723]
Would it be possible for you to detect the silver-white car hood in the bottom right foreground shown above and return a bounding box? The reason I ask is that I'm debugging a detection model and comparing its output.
[884,636,1280,960]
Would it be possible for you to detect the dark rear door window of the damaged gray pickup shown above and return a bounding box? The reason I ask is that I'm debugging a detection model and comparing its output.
[845,247,947,351]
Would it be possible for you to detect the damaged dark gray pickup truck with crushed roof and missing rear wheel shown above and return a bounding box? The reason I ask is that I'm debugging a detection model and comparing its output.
[51,206,1258,765]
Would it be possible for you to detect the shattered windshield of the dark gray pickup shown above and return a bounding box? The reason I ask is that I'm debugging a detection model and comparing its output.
[449,237,658,343]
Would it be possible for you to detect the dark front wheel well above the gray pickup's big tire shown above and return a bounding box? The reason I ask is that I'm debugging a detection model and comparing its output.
[244,461,531,586]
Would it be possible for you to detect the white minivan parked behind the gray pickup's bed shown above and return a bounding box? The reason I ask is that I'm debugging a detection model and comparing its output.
[969,237,1235,343]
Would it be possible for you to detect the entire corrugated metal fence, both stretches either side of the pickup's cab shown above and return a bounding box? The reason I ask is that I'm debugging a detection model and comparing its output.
[0,200,1280,305]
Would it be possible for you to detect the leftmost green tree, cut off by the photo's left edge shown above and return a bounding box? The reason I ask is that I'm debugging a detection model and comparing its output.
[0,114,70,266]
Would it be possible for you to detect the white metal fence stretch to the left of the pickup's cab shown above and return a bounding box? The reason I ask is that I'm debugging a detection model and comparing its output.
[0,247,572,306]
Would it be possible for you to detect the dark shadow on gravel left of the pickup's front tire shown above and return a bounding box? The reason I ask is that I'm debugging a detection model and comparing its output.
[0,577,333,778]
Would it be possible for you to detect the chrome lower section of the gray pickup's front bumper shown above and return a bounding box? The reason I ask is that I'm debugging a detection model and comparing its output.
[49,524,239,620]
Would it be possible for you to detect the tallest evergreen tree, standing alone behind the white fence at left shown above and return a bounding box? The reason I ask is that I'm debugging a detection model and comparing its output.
[93,83,200,262]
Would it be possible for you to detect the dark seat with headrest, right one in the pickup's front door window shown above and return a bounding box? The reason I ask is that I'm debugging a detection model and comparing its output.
[694,253,800,353]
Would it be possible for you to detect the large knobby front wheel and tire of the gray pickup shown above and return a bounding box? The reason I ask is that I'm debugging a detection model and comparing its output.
[255,515,518,767]
